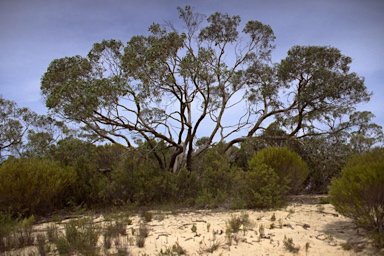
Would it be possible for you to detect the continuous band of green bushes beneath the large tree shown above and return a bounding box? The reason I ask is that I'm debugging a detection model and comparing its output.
[0,140,308,216]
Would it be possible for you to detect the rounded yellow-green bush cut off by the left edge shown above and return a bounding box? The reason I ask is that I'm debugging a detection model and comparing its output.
[0,158,76,216]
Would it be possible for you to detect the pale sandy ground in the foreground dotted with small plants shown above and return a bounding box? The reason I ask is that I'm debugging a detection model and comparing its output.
[7,197,384,256]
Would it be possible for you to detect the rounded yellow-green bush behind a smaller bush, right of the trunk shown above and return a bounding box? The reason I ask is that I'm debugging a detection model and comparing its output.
[248,147,309,194]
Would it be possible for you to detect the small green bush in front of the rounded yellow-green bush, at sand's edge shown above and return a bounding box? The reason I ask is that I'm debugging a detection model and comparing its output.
[232,164,288,208]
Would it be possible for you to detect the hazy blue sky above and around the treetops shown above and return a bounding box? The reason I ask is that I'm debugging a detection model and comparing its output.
[0,0,384,126]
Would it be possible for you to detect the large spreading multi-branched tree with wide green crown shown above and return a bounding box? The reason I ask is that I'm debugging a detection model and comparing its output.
[41,6,370,170]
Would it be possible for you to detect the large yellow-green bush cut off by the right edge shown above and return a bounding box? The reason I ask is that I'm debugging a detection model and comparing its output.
[329,149,384,247]
